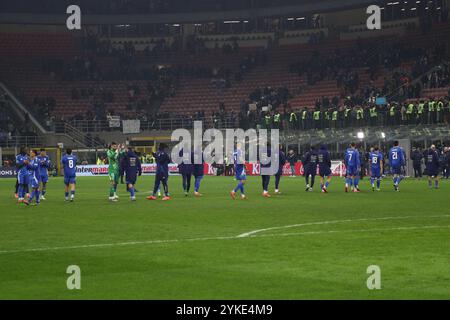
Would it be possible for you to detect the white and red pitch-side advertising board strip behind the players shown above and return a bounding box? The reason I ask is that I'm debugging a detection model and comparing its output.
[77,161,345,176]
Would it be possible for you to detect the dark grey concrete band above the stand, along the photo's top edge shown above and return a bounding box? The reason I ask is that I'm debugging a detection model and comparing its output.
[0,0,384,25]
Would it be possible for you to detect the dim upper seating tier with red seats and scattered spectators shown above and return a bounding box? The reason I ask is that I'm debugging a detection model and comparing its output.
[0,19,450,123]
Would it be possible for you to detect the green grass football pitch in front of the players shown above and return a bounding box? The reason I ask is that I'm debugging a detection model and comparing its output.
[0,176,450,299]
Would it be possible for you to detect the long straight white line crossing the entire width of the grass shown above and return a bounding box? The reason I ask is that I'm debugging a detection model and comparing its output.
[0,216,450,254]
